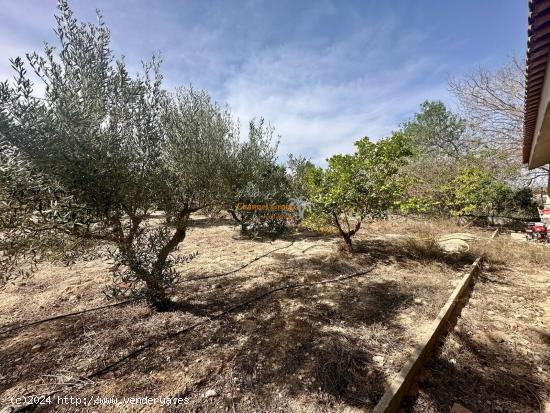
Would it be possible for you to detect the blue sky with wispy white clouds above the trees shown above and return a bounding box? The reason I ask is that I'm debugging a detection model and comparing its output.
[0,0,527,163]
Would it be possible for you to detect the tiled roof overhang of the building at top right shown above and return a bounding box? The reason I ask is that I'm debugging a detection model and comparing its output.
[523,0,550,169]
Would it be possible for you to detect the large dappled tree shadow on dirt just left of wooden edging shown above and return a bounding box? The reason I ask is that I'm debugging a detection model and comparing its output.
[139,266,413,411]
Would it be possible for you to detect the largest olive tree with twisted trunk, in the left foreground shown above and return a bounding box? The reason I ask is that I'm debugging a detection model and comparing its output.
[0,1,243,309]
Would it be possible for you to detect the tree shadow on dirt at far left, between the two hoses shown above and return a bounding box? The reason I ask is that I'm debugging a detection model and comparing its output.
[0,304,149,393]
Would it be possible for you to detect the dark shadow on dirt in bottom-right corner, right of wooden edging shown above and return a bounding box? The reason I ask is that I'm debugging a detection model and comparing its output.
[404,332,550,412]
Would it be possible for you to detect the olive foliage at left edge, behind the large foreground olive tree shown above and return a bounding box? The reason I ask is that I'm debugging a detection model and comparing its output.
[0,141,82,287]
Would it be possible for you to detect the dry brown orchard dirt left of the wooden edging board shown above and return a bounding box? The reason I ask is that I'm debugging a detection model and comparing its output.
[0,217,548,412]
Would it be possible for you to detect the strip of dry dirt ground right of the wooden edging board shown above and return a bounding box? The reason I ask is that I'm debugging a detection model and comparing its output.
[405,233,550,413]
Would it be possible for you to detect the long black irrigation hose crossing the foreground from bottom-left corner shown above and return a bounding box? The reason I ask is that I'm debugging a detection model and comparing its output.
[13,264,376,413]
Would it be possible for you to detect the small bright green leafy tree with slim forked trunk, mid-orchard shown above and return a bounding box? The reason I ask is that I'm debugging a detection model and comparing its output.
[307,134,410,252]
